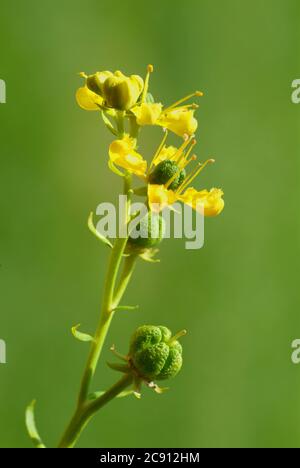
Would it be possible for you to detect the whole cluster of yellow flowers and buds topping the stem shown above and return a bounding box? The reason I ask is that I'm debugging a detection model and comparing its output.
[76,65,224,225]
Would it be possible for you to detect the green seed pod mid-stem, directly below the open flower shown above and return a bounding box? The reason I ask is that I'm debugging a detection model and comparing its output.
[128,211,165,249]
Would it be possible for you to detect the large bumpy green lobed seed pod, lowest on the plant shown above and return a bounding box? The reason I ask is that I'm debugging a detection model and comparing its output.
[129,325,186,380]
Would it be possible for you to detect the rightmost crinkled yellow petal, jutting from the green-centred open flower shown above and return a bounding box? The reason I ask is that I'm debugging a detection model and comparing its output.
[179,187,224,216]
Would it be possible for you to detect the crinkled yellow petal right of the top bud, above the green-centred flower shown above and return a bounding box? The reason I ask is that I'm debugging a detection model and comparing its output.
[158,108,198,137]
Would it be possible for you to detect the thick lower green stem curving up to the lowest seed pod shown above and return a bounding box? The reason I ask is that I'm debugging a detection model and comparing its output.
[58,374,133,448]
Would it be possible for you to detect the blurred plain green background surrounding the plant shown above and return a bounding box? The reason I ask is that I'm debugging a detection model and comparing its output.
[0,0,300,447]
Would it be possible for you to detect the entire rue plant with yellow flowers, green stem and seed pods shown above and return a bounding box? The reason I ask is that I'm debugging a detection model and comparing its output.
[26,65,224,448]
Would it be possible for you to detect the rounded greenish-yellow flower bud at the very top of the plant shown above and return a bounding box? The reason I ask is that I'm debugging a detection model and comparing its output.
[101,71,144,110]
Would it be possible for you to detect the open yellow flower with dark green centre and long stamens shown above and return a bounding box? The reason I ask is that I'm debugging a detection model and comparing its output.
[148,136,224,216]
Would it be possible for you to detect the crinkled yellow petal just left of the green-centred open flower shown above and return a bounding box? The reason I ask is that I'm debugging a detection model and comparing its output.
[109,135,147,178]
